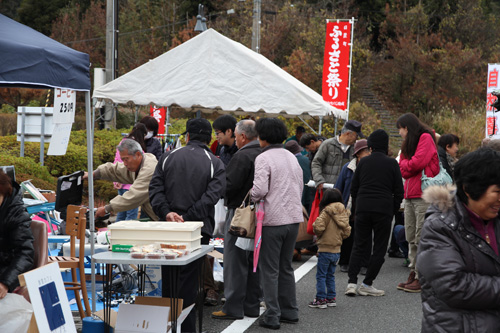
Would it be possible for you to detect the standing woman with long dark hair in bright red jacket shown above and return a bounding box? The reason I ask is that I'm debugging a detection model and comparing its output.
[396,113,439,292]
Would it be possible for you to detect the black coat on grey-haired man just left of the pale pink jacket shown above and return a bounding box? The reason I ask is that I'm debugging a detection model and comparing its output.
[224,140,262,208]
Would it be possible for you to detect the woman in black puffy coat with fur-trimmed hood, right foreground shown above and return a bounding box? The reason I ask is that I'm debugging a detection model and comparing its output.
[417,148,500,332]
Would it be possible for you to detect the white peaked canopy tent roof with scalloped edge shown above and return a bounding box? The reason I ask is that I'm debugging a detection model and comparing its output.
[93,29,347,119]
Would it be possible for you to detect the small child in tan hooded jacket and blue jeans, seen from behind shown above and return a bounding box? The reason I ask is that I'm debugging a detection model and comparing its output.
[309,189,351,309]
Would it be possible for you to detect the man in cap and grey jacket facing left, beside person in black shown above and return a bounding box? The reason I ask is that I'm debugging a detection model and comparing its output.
[311,120,365,190]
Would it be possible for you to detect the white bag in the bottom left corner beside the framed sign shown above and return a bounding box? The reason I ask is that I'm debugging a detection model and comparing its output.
[0,293,33,333]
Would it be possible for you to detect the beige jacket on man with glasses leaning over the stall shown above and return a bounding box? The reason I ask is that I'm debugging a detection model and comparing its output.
[94,153,158,221]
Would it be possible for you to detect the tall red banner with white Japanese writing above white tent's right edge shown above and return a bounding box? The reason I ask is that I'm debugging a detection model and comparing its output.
[322,21,352,110]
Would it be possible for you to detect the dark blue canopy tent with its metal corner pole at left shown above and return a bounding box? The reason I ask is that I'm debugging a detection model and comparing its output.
[0,14,95,312]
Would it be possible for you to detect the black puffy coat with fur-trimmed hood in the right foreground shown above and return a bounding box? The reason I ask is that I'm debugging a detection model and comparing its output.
[417,186,500,333]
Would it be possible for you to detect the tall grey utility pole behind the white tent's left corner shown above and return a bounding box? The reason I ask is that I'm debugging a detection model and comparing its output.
[104,0,118,129]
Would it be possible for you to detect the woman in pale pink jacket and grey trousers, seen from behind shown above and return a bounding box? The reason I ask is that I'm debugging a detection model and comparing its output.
[251,118,304,329]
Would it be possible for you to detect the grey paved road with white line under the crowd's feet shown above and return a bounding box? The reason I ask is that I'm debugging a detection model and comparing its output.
[203,256,422,333]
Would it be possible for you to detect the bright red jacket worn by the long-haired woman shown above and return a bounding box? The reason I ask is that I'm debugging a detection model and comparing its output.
[399,133,439,199]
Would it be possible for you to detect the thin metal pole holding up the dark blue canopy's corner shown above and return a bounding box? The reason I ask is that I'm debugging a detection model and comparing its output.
[87,91,96,313]
